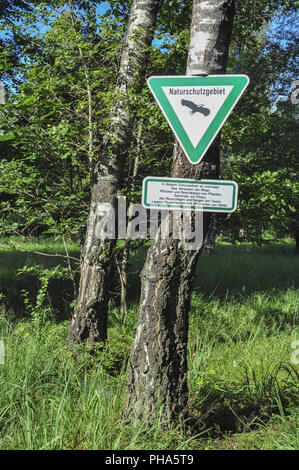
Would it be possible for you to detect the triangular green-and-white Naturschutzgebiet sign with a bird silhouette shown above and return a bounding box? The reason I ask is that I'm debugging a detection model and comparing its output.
[148,75,249,164]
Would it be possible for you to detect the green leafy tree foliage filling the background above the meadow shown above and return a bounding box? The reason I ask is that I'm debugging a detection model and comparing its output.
[0,0,298,241]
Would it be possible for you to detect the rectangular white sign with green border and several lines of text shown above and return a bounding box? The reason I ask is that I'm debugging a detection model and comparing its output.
[142,176,238,212]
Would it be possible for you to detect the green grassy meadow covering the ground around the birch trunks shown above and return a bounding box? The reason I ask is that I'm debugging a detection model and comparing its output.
[0,240,299,450]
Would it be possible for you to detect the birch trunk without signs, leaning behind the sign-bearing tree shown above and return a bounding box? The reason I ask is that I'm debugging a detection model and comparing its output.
[67,0,160,347]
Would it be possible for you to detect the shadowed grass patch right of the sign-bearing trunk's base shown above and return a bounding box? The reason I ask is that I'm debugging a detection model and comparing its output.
[190,365,299,438]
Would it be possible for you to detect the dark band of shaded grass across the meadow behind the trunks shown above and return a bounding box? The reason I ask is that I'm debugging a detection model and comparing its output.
[0,243,299,320]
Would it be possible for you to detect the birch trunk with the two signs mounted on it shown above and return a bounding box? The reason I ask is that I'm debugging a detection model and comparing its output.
[124,0,234,427]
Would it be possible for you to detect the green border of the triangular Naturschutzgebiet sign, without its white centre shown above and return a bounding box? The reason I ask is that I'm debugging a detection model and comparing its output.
[147,75,249,164]
